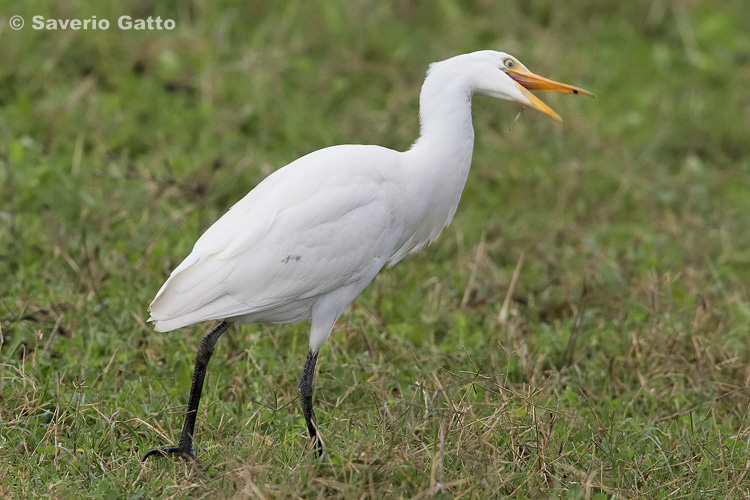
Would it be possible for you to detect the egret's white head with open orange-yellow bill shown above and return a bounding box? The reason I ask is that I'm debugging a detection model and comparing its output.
[438,50,594,121]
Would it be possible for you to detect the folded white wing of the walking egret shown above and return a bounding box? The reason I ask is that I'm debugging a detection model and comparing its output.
[149,146,398,331]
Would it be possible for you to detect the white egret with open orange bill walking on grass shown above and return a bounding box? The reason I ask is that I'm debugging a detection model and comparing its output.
[143,50,593,460]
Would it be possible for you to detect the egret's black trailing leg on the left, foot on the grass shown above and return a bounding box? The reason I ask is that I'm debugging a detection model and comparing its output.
[143,321,230,461]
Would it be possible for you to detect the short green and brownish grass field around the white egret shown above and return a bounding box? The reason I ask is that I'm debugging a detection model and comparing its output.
[0,0,750,499]
